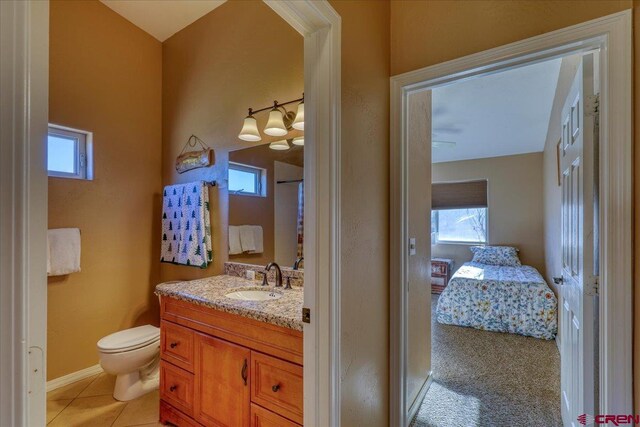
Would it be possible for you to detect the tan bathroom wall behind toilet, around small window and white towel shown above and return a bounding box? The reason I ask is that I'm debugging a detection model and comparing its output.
[47,1,162,379]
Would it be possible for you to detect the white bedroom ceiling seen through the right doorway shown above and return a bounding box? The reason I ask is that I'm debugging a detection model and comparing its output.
[432,59,561,163]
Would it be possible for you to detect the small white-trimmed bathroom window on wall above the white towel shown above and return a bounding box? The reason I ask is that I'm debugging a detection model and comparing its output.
[47,124,93,179]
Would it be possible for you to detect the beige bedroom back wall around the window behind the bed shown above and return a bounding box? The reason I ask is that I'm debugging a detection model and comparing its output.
[432,153,545,274]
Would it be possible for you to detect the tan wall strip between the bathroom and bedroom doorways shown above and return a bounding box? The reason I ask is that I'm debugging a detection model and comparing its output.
[331,1,389,427]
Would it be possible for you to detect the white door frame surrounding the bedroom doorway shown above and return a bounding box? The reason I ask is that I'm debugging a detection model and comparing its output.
[389,10,633,427]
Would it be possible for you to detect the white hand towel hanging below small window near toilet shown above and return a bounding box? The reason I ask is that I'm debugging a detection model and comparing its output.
[47,228,80,276]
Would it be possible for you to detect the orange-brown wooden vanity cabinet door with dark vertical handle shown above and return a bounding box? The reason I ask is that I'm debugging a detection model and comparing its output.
[195,334,251,427]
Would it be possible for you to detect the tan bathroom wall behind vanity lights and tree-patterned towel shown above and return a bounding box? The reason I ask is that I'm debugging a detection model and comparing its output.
[161,1,304,280]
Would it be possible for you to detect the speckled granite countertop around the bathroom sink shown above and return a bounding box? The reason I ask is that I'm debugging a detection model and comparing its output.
[155,275,303,331]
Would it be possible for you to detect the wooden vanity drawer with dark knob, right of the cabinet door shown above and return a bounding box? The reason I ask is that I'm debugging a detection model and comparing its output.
[251,351,303,424]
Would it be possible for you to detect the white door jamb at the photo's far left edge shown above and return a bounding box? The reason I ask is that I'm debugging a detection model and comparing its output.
[0,1,49,426]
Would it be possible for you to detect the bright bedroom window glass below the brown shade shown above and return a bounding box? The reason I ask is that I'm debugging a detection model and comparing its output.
[431,208,487,244]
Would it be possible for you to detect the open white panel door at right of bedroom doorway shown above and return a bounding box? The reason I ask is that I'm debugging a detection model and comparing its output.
[559,54,597,426]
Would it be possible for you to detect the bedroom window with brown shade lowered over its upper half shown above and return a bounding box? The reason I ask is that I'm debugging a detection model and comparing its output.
[431,180,489,244]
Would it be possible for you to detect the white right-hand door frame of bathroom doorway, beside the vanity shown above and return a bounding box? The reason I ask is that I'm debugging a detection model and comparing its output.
[263,0,342,427]
